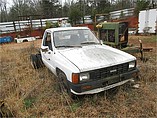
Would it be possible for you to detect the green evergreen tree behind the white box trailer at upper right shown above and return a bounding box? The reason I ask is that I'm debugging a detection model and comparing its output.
[134,0,149,16]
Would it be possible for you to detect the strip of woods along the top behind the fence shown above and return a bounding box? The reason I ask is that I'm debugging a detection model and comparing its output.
[0,0,157,22]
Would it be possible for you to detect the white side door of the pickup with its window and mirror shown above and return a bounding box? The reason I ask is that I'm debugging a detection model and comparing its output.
[41,32,55,73]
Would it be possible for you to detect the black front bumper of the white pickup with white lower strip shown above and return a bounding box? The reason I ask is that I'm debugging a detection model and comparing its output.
[69,68,139,95]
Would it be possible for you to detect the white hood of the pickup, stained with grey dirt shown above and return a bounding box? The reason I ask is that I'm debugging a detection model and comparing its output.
[59,45,136,72]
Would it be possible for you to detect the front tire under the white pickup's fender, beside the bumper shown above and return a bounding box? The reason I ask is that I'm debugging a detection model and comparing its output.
[57,71,75,99]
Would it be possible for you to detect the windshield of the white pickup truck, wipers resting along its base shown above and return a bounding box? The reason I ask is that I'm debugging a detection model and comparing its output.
[54,29,99,47]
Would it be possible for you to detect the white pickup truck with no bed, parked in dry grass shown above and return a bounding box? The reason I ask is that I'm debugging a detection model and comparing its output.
[31,27,138,95]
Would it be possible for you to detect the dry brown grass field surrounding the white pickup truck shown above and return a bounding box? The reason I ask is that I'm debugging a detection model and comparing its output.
[0,37,157,118]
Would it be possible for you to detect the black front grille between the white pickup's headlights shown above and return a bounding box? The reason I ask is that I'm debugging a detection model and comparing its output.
[90,63,128,79]
